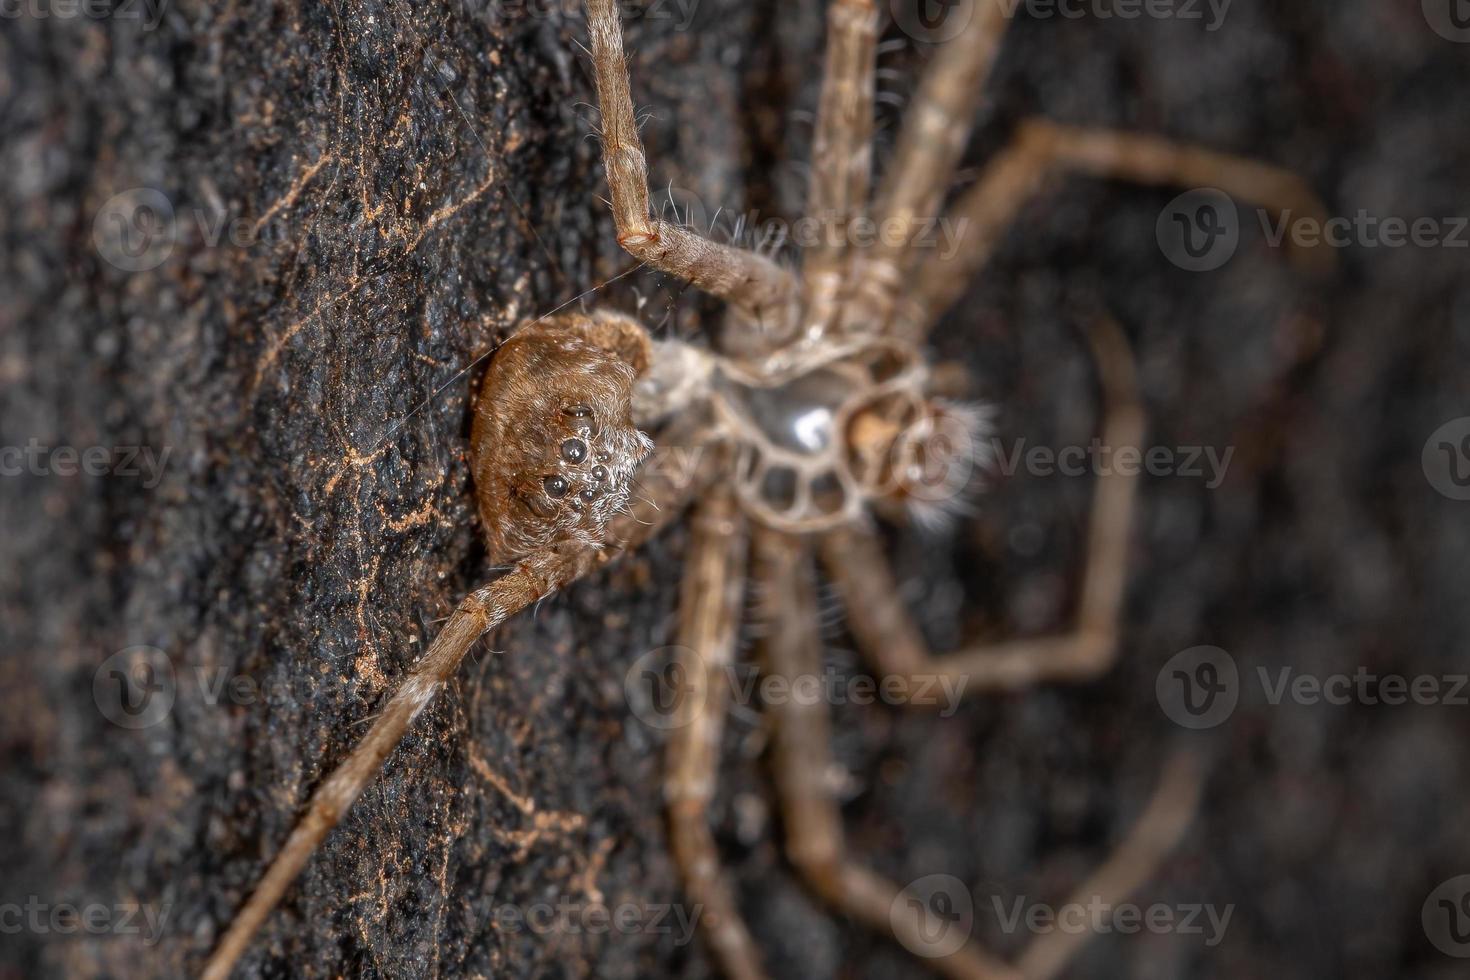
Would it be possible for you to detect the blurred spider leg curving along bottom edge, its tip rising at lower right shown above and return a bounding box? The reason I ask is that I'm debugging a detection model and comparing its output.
[756,530,1200,980]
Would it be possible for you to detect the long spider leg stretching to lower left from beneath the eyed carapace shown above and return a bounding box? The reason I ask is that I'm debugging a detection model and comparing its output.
[200,458,700,980]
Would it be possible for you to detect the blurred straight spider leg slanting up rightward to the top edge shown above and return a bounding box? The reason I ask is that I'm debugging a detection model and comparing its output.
[848,0,1014,332]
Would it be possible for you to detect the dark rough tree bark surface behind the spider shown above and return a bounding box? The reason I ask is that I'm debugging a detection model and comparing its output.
[0,0,1470,977]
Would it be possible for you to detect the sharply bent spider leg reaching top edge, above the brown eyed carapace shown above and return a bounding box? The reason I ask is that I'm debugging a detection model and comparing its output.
[587,0,795,329]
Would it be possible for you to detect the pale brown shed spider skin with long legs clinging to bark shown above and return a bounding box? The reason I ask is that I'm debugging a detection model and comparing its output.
[203,0,1322,980]
